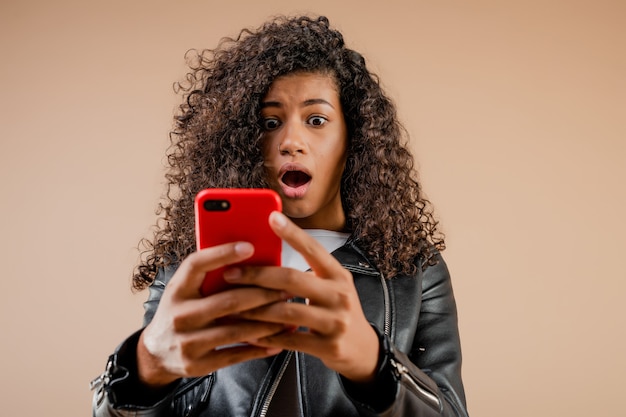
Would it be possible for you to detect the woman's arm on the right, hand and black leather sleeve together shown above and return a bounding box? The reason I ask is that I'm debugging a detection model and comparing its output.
[224,213,466,417]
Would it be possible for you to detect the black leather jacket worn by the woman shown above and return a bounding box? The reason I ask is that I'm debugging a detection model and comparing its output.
[92,242,467,417]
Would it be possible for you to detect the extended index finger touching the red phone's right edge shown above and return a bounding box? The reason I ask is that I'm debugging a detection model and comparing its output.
[269,211,342,277]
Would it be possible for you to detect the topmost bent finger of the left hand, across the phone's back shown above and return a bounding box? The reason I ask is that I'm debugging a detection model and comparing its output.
[168,242,254,298]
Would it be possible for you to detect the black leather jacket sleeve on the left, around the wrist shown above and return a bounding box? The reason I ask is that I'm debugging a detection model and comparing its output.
[91,270,179,417]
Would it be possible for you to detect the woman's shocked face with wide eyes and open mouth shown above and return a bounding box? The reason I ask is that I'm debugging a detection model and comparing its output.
[261,73,347,230]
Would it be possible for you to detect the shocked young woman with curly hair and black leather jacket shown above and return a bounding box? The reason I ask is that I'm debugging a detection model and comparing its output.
[94,17,467,416]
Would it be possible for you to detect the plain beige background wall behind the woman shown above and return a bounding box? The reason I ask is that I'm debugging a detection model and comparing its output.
[0,0,626,417]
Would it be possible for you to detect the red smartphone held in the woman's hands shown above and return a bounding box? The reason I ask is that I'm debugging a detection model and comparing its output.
[195,188,282,296]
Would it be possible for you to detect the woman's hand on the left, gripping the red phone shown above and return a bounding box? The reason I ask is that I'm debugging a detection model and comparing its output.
[137,242,289,388]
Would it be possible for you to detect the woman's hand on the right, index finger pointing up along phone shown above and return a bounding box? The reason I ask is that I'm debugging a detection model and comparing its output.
[224,212,379,383]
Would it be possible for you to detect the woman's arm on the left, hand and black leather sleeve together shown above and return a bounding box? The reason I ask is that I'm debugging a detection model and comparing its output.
[93,242,284,416]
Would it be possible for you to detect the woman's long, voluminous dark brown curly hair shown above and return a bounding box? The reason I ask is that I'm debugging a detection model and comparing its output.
[133,16,445,290]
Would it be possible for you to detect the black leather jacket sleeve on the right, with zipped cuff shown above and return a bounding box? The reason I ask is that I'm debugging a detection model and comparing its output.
[343,255,468,417]
